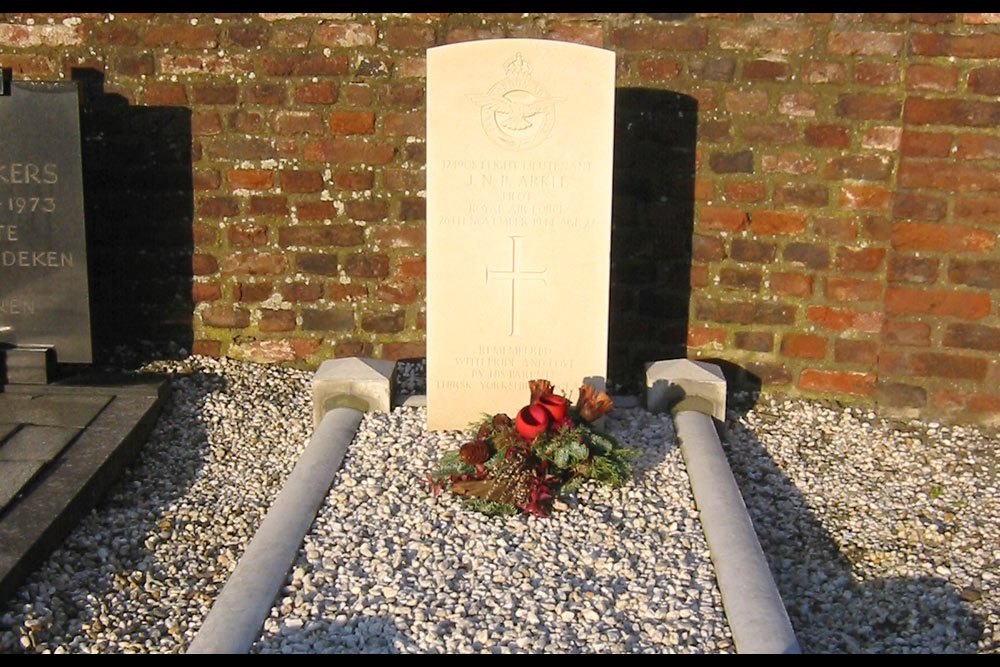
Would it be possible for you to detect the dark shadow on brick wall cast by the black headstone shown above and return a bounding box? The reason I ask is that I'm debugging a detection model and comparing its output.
[72,69,194,362]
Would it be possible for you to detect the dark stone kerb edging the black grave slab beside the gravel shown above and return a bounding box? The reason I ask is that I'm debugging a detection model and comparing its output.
[0,379,169,600]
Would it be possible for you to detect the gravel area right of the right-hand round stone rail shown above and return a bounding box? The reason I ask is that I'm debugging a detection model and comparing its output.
[723,397,1000,653]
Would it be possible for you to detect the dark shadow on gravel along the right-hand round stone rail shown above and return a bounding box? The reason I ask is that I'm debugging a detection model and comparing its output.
[721,393,984,653]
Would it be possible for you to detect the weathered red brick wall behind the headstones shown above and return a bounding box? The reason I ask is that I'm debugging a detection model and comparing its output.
[0,14,1000,419]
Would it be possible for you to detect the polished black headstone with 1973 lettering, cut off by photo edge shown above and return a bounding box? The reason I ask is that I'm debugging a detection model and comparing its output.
[0,82,91,362]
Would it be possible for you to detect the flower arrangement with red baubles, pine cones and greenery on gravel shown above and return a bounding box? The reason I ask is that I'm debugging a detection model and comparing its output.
[428,380,638,517]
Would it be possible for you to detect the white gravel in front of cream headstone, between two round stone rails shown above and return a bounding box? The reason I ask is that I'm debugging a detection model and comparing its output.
[256,408,732,653]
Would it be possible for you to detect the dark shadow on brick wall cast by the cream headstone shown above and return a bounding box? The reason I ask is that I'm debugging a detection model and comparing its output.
[608,88,698,392]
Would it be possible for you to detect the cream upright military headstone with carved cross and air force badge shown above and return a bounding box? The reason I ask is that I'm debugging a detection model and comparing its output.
[427,39,615,429]
